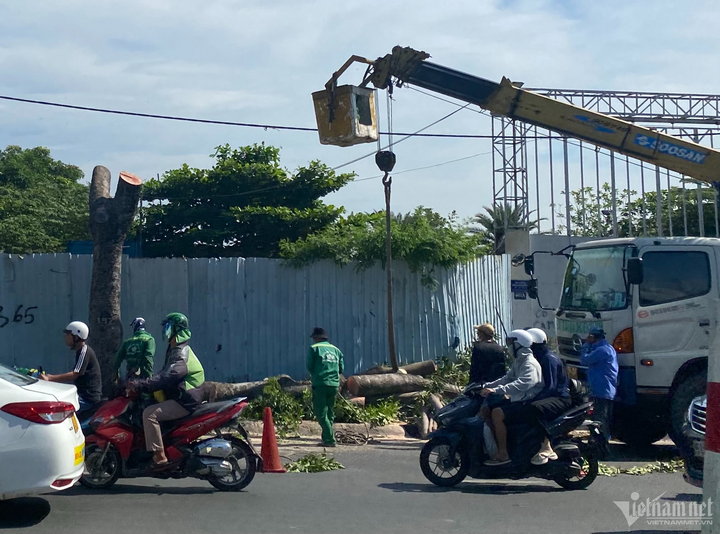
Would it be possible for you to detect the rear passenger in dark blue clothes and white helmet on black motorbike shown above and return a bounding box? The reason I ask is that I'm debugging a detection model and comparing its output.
[527,328,572,465]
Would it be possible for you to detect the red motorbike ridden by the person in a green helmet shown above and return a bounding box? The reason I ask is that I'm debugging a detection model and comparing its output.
[80,396,262,491]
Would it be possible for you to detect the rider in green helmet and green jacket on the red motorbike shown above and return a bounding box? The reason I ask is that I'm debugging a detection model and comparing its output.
[128,313,205,466]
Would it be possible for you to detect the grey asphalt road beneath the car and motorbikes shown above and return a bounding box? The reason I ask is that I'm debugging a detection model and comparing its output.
[0,442,701,534]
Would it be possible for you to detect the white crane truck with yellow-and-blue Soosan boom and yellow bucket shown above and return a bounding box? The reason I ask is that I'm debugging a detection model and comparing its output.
[313,46,720,445]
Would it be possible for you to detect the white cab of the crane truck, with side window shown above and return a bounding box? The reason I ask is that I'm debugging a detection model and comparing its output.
[556,238,720,445]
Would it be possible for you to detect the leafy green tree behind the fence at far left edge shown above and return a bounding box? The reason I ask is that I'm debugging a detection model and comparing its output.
[0,145,90,254]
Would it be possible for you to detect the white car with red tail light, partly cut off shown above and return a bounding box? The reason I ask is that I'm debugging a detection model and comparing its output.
[0,365,85,501]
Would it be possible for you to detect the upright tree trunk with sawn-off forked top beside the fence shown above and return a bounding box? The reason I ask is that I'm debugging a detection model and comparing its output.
[88,165,142,396]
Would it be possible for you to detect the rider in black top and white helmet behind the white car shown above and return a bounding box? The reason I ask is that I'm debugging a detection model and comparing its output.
[40,321,102,413]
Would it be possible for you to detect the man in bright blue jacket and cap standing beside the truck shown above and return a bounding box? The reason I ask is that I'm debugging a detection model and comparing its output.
[580,327,618,444]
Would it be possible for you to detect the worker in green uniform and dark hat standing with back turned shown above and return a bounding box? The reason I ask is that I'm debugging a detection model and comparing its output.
[306,328,344,447]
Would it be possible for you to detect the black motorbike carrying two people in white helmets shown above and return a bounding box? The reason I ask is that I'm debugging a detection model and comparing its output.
[420,385,607,490]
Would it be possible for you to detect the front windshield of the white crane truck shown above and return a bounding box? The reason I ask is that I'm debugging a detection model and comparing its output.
[560,246,627,311]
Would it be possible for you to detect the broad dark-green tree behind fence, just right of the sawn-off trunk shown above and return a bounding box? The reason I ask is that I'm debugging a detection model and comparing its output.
[136,144,354,258]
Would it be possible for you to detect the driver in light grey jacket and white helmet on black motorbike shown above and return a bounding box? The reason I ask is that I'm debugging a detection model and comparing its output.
[480,330,544,466]
